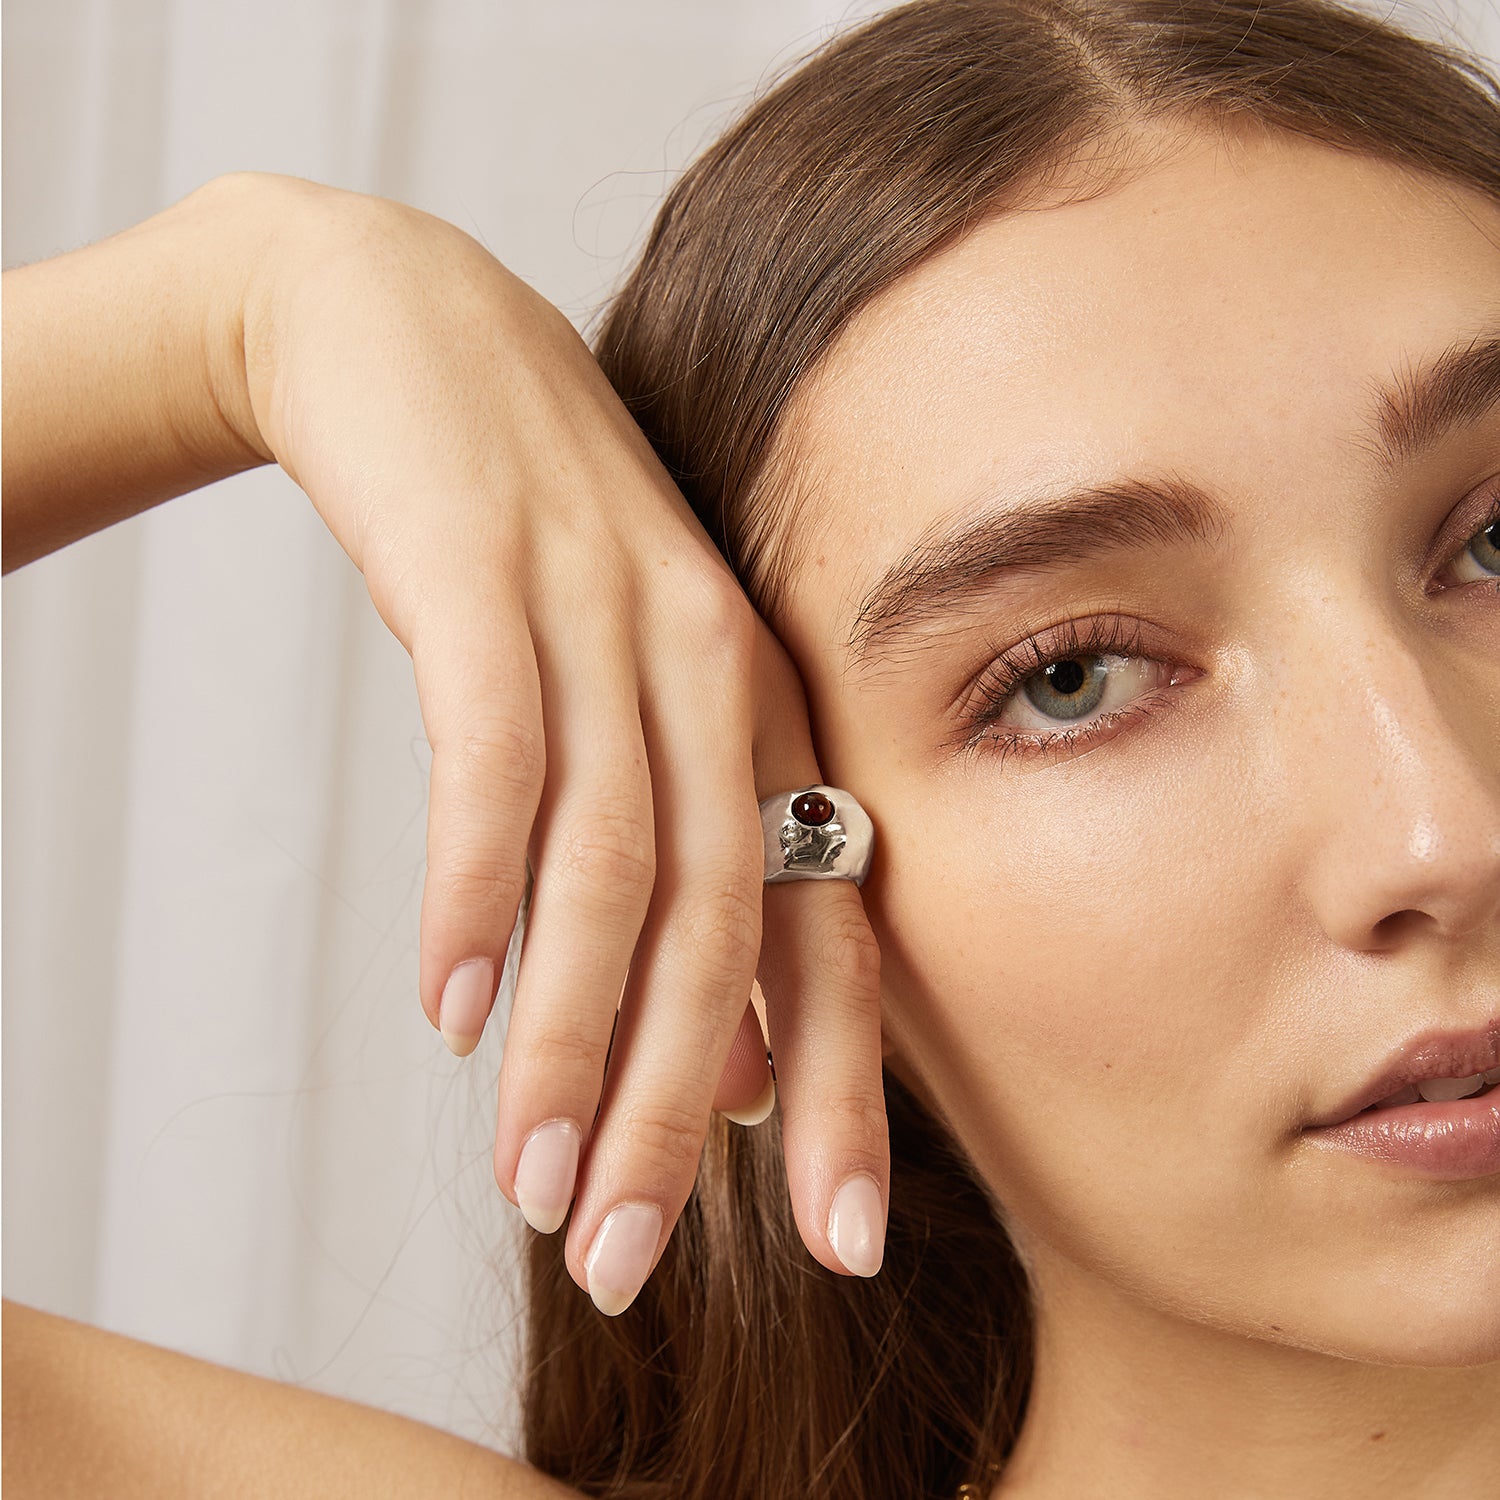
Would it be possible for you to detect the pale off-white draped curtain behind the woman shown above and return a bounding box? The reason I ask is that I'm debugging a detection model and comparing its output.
[3,0,1500,1448]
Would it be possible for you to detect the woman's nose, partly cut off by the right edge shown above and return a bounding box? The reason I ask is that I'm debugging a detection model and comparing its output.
[1295,621,1500,962]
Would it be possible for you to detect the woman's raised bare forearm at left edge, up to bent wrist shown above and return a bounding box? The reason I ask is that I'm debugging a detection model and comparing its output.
[3,173,303,570]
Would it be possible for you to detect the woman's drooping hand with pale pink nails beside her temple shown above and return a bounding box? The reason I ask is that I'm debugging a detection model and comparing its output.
[229,170,888,1313]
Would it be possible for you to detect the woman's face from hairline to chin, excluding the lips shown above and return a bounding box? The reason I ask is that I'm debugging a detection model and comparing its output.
[776,120,1500,1364]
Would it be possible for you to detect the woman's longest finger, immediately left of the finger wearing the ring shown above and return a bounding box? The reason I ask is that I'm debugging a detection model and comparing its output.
[567,573,764,1314]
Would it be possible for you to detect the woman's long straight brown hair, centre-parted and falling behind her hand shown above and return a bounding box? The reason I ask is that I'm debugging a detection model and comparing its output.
[524,0,1500,1500]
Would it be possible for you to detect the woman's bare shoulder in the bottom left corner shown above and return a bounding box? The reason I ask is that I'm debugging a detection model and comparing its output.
[0,1302,578,1500]
